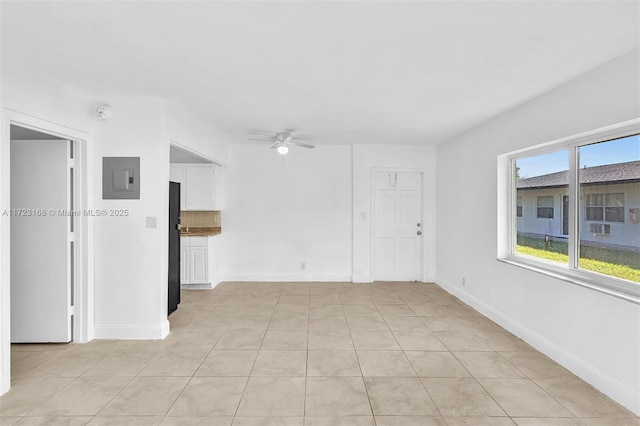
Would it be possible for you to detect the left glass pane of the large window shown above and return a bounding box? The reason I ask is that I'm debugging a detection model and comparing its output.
[513,149,568,264]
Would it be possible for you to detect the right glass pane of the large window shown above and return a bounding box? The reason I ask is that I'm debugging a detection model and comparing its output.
[578,135,640,282]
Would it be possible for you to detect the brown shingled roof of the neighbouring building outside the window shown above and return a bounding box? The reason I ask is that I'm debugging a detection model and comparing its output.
[516,161,640,189]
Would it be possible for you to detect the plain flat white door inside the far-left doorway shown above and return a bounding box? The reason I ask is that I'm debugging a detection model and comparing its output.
[11,140,72,343]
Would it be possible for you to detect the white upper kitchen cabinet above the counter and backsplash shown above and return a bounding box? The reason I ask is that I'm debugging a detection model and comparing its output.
[169,164,215,210]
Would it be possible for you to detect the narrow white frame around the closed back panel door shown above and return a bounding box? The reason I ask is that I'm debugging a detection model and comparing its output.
[369,167,424,282]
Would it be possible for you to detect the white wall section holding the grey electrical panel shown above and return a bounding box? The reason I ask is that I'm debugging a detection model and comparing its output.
[94,96,169,339]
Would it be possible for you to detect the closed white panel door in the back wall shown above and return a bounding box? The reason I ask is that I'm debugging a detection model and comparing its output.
[372,172,422,281]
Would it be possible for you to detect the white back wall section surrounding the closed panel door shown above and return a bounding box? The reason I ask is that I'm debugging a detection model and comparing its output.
[352,145,436,282]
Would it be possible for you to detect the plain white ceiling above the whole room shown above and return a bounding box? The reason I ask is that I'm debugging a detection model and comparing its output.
[0,0,640,145]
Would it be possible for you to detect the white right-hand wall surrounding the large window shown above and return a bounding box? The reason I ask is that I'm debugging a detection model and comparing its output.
[436,51,640,414]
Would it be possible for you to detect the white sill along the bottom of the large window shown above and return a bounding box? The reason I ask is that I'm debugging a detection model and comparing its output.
[498,255,640,305]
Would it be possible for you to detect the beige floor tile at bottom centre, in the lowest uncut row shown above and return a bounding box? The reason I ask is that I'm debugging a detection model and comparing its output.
[305,377,372,416]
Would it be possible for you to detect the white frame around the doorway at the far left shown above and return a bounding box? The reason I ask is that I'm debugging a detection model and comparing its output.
[0,108,94,394]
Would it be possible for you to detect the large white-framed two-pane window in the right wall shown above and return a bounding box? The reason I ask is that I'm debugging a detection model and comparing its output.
[499,120,640,300]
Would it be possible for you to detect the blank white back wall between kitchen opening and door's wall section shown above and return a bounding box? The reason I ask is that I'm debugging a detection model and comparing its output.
[222,145,351,281]
